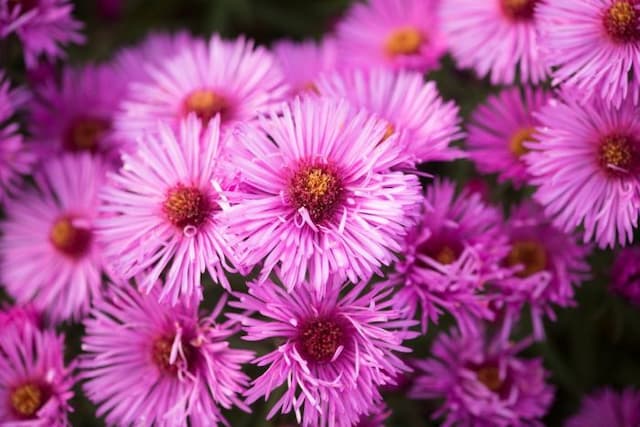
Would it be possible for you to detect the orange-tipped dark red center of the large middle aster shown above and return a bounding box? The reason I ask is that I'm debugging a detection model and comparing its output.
[289,163,344,224]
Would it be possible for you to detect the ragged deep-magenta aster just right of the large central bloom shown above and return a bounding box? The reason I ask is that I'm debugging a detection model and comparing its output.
[385,180,508,332]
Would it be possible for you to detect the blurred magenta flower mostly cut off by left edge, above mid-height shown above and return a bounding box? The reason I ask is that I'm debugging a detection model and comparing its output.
[0,71,34,203]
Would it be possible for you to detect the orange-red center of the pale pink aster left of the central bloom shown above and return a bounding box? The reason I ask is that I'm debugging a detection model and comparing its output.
[162,184,220,229]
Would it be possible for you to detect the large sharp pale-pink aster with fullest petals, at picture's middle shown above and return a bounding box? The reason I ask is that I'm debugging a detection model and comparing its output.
[228,97,422,293]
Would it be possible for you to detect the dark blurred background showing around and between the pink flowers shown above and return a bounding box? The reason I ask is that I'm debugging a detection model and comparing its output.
[5,0,640,427]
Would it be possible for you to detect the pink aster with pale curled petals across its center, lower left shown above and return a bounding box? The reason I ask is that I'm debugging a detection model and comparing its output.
[80,285,253,427]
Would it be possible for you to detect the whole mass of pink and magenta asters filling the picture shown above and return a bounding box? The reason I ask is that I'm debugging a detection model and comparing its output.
[0,0,640,427]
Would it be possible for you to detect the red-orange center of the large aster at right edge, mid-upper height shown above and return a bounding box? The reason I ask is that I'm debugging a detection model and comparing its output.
[599,135,640,175]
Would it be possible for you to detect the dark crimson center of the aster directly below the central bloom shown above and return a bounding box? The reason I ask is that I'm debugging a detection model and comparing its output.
[300,319,344,362]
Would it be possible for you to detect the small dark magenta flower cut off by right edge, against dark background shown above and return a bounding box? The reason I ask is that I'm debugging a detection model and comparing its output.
[611,246,640,306]
